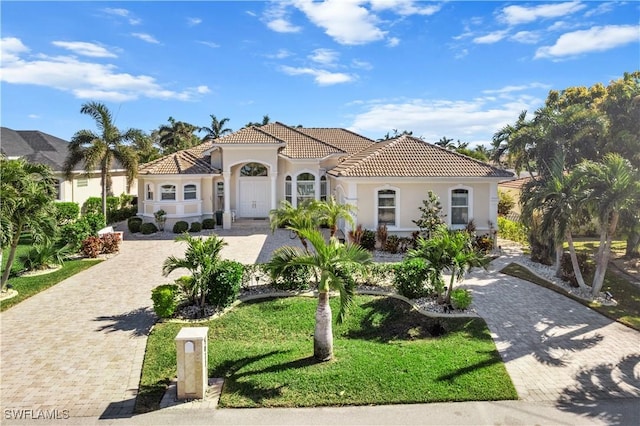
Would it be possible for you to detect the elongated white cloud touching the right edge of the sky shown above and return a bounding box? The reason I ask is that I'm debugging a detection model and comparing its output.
[535,25,640,59]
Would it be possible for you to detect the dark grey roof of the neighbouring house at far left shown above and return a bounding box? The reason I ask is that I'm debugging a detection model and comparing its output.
[0,127,84,172]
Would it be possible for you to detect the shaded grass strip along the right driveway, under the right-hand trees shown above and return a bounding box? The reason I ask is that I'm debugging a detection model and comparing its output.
[500,263,640,331]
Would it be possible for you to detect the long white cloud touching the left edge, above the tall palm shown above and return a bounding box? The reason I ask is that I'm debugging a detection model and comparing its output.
[0,38,209,102]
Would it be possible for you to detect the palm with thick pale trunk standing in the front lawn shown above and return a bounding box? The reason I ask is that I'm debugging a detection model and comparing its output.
[267,229,371,361]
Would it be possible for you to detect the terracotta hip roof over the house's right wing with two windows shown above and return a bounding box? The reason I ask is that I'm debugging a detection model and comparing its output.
[327,136,513,178]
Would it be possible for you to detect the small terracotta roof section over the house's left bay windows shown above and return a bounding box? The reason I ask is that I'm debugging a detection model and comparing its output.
[138,142,220,175]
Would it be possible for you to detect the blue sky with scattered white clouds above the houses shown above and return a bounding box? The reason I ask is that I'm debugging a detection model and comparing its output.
[0,0,640,143]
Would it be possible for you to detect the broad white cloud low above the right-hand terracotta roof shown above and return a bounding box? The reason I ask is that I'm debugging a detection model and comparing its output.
[349,95,543,143]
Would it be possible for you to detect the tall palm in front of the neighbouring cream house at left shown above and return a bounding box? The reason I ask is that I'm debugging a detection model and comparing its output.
[62,102,141,219]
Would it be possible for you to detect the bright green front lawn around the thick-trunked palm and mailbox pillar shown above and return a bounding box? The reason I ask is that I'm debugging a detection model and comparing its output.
[136,296,517,412]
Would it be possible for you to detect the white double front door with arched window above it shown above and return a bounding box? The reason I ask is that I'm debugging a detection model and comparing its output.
[237,162,271,218]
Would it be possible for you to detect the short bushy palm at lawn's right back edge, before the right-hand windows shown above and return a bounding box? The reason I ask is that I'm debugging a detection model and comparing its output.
[407,225,490,304]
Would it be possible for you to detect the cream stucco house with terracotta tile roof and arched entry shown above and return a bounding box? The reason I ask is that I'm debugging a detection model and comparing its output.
[138,122,513,235]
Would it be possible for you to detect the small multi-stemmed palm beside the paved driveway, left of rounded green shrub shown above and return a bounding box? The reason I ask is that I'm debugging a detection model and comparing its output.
[162,233,227,314]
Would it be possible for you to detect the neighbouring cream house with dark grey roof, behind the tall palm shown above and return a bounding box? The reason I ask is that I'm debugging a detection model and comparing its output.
[0,127,138,207]
